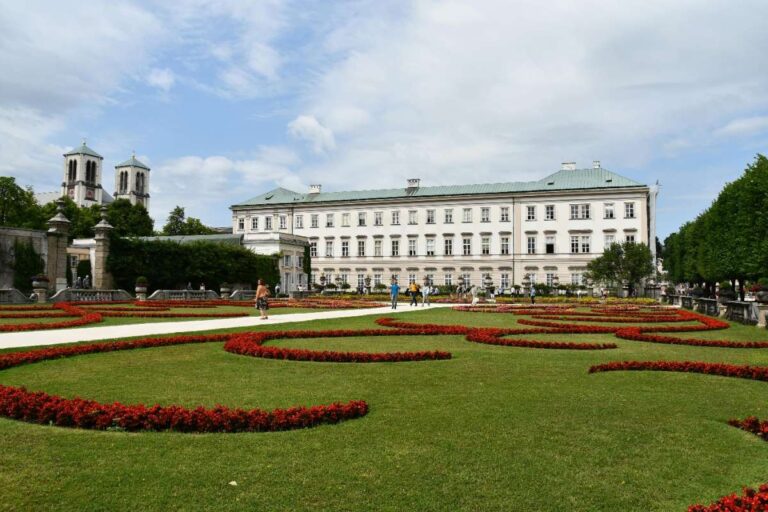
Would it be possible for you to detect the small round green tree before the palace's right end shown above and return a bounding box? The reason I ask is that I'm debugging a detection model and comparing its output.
[587,242,656,295]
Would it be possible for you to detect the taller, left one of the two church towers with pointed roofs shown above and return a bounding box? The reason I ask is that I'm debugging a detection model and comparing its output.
[61,139,104,206]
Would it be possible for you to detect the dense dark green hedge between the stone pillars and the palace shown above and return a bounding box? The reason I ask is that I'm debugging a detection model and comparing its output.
[107,237,280,290]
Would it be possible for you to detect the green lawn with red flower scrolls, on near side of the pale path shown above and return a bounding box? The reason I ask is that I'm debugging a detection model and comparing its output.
[0,308,768,511]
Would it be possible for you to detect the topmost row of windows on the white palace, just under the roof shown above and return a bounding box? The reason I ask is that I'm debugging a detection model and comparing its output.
[238,202,635,231]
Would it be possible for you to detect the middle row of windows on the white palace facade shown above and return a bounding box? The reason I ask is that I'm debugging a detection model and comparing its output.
[309,234,635,258]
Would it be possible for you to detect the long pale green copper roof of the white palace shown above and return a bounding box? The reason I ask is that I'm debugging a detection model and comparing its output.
[230,168,644,208]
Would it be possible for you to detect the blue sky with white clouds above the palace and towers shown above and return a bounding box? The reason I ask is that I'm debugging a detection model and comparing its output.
[0,0,768,239]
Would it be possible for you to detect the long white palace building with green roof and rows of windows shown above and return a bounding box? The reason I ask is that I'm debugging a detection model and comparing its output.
[230,161,658,291]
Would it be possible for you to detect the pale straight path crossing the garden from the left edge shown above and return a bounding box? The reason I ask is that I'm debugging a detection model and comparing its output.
[0,304,453,348]
